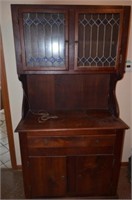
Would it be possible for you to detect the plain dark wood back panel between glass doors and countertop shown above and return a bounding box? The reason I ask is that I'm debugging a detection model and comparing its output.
[27,74,110,111]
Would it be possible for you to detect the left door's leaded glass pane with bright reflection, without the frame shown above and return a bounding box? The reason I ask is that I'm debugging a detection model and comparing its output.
[23,13,65,67]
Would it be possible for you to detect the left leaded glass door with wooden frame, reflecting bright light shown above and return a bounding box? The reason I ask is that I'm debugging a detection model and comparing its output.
[20,9,68,70]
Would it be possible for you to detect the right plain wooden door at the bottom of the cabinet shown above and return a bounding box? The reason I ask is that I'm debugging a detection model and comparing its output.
[75,156,113,196]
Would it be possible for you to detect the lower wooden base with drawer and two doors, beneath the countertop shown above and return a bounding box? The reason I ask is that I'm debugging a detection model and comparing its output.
[19,130,124,199]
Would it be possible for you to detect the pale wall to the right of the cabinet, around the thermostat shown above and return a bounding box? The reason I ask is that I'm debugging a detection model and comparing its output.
[117,1,132,161]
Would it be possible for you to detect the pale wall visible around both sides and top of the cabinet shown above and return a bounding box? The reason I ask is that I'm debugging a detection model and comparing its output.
[0,0,132,164]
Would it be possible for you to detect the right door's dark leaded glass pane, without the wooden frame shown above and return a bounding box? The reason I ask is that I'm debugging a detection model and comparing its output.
[78,13,120,66]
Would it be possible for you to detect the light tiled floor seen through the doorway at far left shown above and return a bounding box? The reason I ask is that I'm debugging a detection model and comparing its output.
[0,110,12,168]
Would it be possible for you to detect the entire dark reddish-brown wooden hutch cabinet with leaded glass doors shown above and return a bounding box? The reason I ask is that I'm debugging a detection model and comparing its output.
[11,5,130,198]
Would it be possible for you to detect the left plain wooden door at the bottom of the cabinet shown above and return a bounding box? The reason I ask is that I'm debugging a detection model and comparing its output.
[29,157,66,197]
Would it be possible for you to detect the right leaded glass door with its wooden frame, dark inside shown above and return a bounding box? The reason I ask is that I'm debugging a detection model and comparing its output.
[75,9,122,70]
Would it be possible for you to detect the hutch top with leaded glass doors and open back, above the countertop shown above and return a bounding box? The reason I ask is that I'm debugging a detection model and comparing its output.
[12,5,130,116]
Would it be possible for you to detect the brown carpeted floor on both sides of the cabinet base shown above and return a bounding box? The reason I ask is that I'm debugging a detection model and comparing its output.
[1,166,131,200]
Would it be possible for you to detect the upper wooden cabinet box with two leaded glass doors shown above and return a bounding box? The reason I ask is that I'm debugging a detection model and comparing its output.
[12,5,130,73]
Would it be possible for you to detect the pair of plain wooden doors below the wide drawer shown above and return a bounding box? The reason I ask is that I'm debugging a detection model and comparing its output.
[25,155,114,198]
